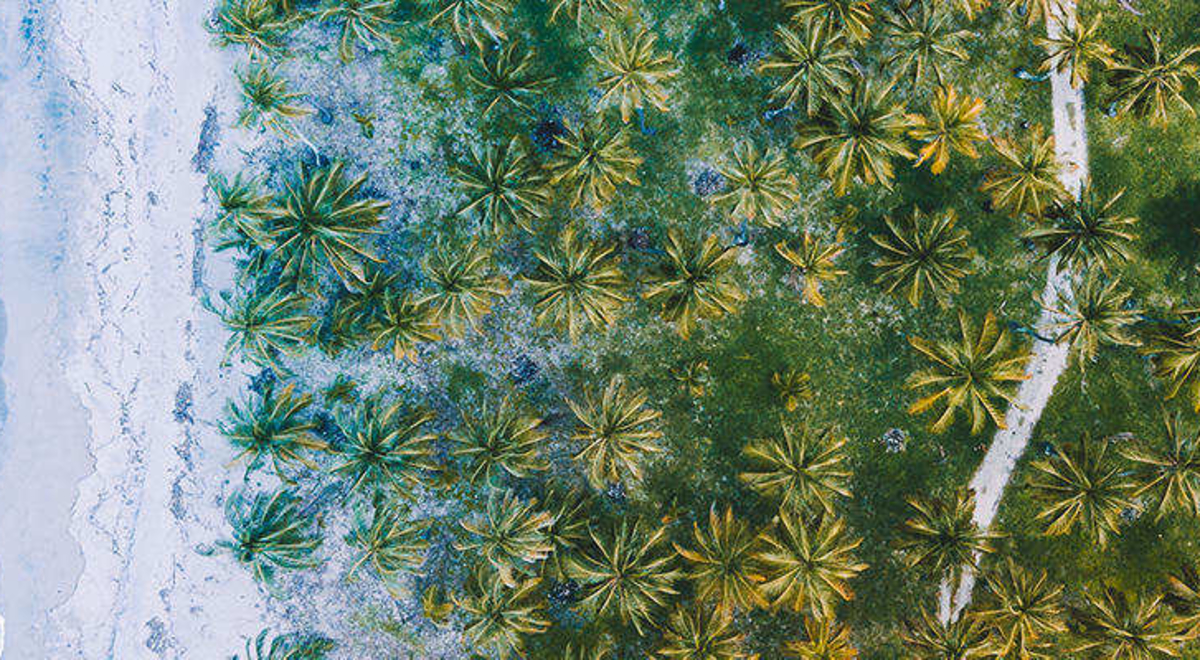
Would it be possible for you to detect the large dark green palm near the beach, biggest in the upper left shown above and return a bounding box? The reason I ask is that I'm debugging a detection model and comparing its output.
[271,162,389,289]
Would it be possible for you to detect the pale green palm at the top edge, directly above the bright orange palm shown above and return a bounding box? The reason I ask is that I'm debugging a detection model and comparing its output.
[884,2,971,86]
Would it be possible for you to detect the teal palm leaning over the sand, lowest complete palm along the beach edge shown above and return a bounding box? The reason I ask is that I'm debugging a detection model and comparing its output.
[217,490,320,592]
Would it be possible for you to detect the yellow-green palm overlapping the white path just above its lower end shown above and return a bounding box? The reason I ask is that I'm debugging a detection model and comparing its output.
[900,488,1000,576]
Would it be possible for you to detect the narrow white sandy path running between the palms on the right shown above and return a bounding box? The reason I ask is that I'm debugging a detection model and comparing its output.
[938,0,1087,620]
